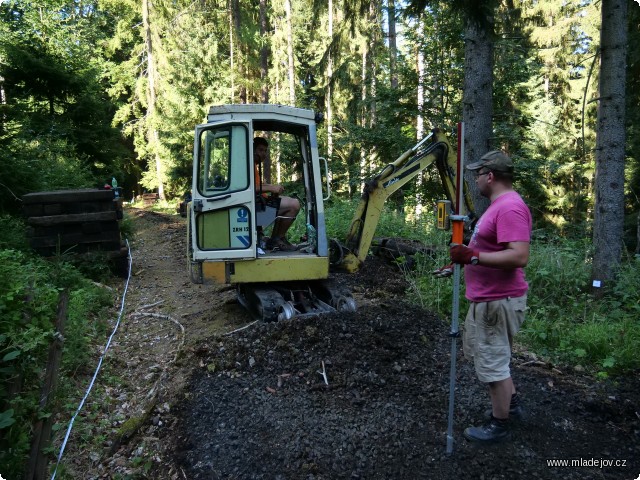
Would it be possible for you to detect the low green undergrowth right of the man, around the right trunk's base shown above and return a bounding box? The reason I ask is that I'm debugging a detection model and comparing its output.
[522,246,640,376]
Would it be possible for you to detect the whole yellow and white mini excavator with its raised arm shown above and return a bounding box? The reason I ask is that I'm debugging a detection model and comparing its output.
[187,104,473,321]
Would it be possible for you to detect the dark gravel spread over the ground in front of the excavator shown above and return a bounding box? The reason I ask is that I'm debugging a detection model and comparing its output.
[173,261,640,479]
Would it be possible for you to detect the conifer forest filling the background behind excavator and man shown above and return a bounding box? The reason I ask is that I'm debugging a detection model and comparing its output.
[0,0,640,476]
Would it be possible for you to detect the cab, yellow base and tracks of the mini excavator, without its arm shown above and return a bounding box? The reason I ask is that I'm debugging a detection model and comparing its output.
[188,105,355,320]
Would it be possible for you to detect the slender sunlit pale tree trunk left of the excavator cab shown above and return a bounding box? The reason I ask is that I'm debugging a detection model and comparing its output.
[142,0,165,200]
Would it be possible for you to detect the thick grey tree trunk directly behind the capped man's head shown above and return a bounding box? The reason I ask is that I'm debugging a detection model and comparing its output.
[462,20,493,215]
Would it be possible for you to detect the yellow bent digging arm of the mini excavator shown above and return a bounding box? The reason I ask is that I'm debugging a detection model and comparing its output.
[332,129,474,272]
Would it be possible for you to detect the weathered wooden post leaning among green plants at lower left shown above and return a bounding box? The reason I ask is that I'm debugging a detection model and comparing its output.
[24,290,69,480]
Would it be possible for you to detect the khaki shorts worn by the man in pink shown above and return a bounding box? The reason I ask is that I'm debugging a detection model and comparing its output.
[463,295,527,383]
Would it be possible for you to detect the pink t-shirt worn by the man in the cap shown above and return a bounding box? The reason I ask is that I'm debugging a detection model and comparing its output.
[464,191,532,302]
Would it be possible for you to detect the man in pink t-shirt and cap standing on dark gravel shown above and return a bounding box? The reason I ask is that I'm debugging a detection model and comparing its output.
[450,150,532,443]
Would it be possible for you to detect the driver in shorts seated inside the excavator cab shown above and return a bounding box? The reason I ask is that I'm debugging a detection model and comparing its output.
[253,137,300,252]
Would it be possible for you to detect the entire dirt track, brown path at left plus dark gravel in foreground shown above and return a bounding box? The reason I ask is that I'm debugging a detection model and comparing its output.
[58,210,640,479]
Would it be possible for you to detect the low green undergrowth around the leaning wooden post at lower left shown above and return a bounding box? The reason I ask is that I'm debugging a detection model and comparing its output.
[0,249,111,478]
